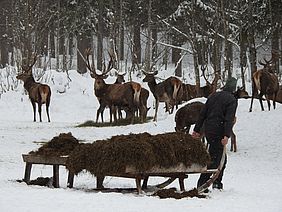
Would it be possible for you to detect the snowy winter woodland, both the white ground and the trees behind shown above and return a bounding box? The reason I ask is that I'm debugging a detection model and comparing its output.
[0,0,282,212]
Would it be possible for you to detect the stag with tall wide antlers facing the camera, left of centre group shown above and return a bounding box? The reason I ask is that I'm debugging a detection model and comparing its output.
[86,49,141,123]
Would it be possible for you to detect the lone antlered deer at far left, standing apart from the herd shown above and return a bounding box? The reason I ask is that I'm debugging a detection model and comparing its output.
[16,56,51,122]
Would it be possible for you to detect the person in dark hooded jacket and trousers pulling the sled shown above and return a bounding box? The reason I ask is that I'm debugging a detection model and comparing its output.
[192,77,238,189]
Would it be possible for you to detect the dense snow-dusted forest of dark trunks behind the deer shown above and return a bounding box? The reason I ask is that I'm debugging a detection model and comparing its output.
[0,0,282,91]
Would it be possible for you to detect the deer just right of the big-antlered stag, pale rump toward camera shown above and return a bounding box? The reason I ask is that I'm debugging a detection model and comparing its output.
[143,71,182,121]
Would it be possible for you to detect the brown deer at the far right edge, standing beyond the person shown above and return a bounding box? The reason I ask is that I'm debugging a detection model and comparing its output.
[249,59,279,112]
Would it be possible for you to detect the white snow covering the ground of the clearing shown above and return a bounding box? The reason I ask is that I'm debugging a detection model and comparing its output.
[0,68,282,212]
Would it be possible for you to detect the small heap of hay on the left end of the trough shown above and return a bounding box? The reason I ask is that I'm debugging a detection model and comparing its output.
[29,133,79,156]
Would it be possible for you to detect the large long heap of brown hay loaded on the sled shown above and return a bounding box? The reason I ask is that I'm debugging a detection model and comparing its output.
[66,132,210,176]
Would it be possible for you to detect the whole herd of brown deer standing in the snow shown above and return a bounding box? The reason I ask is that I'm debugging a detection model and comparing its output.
[16,49,282,151]
